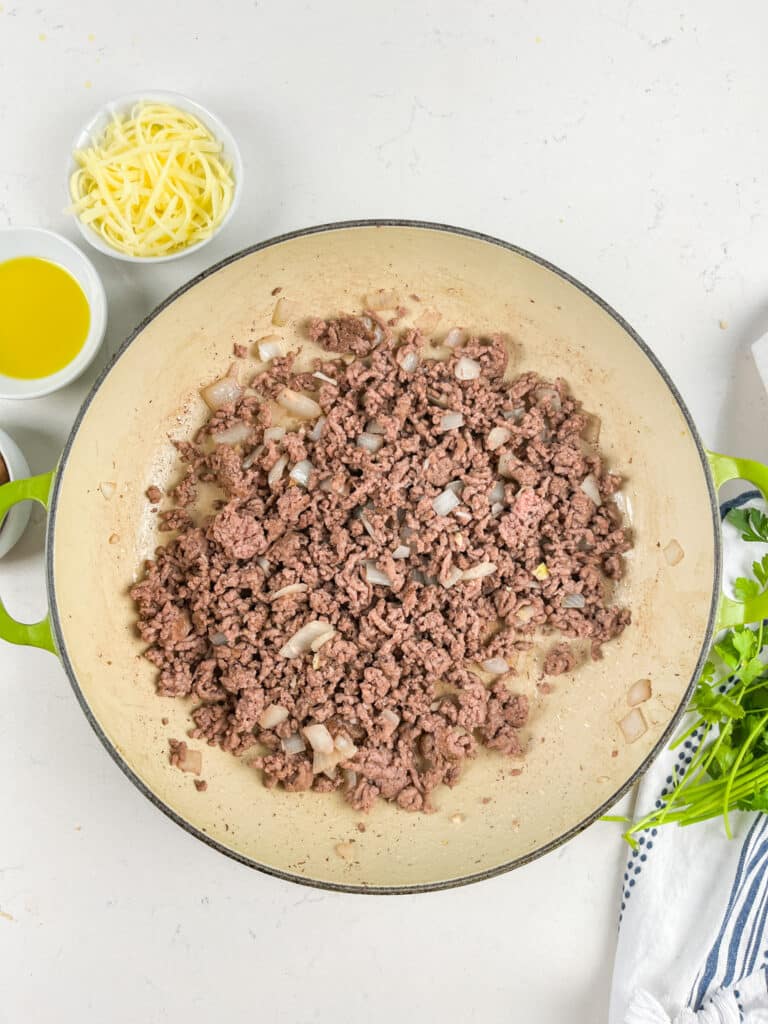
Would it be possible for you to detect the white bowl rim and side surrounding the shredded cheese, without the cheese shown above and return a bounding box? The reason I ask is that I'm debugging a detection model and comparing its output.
[67,89,243,263]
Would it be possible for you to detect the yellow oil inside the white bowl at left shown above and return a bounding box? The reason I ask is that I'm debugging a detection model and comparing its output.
[0,256,91,380]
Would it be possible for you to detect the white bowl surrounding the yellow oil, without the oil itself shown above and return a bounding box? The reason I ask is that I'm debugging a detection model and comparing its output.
[0,227,106,398]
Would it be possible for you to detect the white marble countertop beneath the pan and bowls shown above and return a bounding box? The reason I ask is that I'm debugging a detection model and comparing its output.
[0,0,768,1024]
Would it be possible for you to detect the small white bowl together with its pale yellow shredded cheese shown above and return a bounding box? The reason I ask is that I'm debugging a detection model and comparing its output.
[68,92,243,263]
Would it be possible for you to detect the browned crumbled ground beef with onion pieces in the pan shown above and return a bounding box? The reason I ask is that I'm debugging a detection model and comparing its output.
[131,316,631,810]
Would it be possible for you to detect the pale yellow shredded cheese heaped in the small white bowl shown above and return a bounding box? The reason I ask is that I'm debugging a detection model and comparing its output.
[70,102,234,258]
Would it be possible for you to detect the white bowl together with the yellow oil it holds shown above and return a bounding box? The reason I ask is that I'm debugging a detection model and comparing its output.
[0,227,106,398]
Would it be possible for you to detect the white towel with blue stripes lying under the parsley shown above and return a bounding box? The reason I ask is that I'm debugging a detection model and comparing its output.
[609,492,768,1024]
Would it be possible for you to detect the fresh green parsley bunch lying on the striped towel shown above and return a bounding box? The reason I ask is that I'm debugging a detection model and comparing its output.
[612,509,768,847]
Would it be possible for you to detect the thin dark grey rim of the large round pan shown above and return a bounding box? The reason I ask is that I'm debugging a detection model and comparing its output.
[45,218,722,896]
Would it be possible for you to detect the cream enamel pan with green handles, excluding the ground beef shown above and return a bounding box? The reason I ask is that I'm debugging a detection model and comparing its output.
[6,222,765,892]
